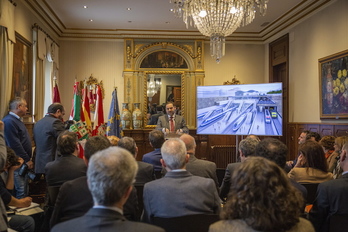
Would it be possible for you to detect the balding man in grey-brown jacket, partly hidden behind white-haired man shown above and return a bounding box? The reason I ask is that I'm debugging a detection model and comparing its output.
[180,134,219,190]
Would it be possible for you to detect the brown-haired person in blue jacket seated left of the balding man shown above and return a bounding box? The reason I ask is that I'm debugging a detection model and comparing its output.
[142,130,165,171]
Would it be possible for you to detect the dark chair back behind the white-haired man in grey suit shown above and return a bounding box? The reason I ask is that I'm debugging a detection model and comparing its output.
[153,214,219,232]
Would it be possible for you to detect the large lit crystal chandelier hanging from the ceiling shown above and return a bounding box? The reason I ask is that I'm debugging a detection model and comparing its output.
[170,0,268,63]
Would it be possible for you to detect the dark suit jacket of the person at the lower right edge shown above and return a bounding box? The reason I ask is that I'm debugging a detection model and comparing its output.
[309,174,348,232]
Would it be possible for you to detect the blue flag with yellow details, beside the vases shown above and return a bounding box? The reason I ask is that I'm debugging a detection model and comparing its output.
[106,88,121,138]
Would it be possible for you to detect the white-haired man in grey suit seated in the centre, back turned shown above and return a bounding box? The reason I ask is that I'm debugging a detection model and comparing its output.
[143,138,220,222]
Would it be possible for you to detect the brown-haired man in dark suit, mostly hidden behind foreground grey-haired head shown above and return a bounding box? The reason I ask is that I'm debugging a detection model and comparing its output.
[50,135,138,227]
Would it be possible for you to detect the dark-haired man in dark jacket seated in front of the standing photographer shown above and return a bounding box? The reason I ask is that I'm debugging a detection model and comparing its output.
[45,131,87,186]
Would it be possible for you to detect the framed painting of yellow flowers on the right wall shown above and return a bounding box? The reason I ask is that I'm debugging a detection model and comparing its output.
[319,50,348,119]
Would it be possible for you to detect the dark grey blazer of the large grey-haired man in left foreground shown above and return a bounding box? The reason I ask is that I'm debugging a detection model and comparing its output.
[51,208,164,232]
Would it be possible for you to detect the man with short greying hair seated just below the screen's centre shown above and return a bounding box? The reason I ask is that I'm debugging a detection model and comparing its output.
[220,138,259,200]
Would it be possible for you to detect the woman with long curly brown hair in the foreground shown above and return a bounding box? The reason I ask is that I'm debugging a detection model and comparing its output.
[209,157,314,232]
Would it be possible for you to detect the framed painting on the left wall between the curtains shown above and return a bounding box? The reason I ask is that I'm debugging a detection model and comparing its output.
[11,33,33,116]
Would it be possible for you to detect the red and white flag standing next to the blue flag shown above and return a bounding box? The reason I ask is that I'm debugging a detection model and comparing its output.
[92,85,106,136]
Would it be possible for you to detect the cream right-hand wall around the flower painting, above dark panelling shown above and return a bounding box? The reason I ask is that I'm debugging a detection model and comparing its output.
[289,0,348,123]
